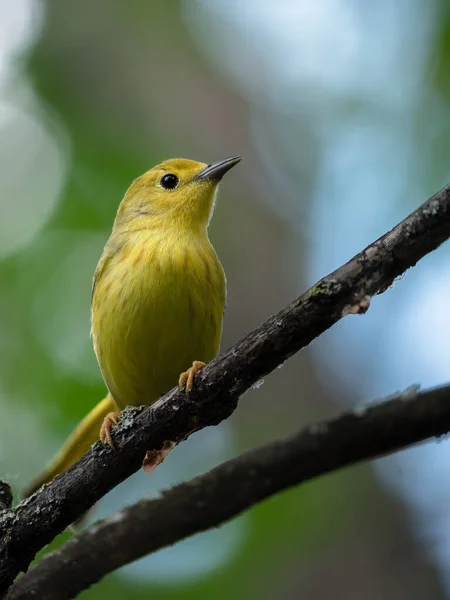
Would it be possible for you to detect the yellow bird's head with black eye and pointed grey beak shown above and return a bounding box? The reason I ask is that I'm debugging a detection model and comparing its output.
[116,156,241,229]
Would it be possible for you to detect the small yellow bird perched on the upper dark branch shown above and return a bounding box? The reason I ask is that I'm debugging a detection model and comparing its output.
[25,156,241,495]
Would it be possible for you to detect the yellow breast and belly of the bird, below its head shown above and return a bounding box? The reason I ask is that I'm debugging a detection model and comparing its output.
[92,234,225,406]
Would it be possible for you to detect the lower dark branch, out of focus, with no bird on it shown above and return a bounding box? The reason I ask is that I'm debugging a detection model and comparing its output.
[8,386,450,600]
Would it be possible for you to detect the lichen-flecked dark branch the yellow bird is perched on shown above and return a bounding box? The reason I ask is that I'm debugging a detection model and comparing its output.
[0,187,450,595]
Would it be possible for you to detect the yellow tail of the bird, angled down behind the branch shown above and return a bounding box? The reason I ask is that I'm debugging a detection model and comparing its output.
[23,394,119,498]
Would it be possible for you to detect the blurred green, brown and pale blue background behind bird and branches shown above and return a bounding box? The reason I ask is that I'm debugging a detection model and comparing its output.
[0,0,450,600]
